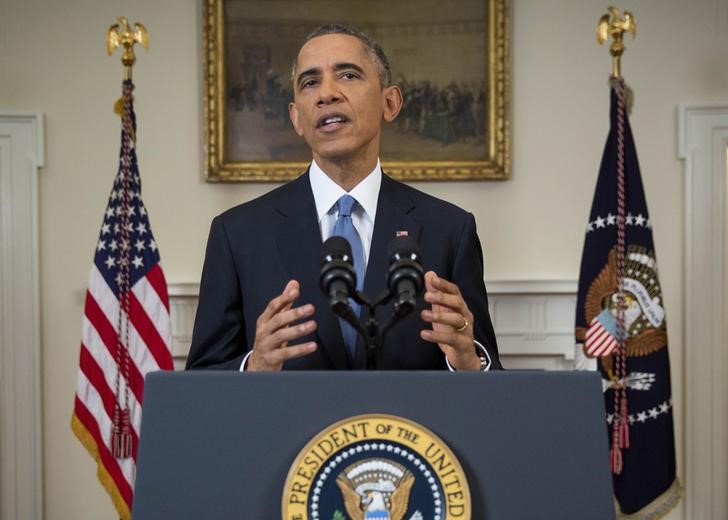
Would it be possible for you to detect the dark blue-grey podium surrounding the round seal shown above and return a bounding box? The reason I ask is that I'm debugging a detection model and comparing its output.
[132,371,615,520]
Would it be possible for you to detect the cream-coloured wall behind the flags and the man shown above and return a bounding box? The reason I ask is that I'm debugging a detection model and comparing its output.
[0,0,728,519]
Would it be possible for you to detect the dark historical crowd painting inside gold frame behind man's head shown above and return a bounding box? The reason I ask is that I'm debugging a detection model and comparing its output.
[206,0,507,178]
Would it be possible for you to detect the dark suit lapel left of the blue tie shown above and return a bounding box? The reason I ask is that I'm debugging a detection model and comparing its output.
[273,172,349,370]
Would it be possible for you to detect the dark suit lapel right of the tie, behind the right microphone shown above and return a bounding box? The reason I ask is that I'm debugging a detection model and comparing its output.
[354,175,422,368]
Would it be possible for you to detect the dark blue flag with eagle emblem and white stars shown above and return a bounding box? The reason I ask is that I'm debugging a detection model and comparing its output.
[576,79,681,519]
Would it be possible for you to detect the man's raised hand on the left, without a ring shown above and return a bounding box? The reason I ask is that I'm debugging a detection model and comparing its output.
[245,280,316,372]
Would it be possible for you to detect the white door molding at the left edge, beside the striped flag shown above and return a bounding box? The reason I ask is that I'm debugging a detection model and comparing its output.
[0,112,45,519]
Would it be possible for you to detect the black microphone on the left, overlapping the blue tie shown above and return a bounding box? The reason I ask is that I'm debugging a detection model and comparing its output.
[319,236,356,317]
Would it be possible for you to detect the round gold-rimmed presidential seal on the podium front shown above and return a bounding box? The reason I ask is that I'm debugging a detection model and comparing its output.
[281,414,471,520]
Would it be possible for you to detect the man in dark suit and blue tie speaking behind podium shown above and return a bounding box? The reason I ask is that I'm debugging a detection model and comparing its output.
[187,25,501,371]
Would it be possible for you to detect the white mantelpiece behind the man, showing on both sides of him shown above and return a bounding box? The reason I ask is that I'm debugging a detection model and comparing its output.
[168,280,577,370]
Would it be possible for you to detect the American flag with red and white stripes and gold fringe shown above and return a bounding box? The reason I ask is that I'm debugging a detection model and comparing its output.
[71,80,173,519]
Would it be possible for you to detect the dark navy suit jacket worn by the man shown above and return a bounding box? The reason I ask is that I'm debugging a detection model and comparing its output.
[187,173,501,370]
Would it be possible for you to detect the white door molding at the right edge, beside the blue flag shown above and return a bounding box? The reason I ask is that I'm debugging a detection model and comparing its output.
[678,105,728,520]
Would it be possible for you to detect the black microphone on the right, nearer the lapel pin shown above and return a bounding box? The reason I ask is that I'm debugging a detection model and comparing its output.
[387,236,425,319]
